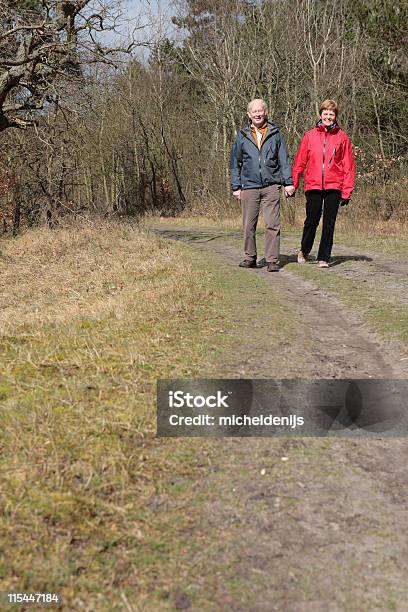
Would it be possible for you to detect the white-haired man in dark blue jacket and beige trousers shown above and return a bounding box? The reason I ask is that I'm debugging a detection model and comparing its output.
[231,99,295,272]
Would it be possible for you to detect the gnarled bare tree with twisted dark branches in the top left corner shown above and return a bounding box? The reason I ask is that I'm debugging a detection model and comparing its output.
[0,0,137,131]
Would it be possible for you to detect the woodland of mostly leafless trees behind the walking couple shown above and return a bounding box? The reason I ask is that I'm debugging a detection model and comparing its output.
[0,0,408,233]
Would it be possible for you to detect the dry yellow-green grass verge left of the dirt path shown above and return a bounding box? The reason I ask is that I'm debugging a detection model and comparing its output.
[0,223,300,611]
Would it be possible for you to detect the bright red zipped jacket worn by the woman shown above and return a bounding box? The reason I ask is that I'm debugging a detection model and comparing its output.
[292,125,355,199]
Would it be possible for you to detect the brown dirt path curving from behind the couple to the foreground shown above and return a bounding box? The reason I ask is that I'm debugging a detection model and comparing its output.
[151,230,408,612]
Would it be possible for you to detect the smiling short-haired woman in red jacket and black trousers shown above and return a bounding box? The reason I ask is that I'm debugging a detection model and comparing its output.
[292,100,355,268]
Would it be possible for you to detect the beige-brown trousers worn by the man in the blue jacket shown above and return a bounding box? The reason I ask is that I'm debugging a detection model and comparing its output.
[241,185,280,263]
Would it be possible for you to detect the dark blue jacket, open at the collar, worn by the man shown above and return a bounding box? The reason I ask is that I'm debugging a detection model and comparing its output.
[231,121,293,191]
